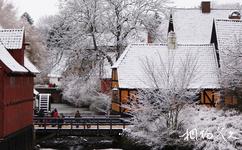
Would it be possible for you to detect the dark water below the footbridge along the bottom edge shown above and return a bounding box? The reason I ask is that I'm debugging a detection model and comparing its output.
[38,136,150,150]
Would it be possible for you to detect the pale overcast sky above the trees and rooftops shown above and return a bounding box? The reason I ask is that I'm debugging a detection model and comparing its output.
[9,0,242,22]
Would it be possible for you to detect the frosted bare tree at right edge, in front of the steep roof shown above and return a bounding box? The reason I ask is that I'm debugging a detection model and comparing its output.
[220,35,242,107]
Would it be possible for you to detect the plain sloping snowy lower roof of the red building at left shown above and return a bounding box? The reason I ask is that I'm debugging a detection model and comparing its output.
[0,43,28,72]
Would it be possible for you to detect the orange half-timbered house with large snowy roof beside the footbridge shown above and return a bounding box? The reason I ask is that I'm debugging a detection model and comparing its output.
[112,43,220,113]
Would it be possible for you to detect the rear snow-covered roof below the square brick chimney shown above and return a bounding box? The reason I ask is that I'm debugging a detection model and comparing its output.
[172,8,236,44]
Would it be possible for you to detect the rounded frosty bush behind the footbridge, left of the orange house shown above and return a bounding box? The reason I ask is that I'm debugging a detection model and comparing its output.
[62,72,110,110]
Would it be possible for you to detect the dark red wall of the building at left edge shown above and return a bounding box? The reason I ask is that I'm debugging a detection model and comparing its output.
[0,73,33,138]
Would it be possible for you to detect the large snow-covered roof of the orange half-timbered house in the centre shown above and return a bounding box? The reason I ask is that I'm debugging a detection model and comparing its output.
[112,44,219,89]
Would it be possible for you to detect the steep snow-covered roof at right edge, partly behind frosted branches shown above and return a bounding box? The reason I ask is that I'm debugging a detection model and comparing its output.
[214,19,242,67]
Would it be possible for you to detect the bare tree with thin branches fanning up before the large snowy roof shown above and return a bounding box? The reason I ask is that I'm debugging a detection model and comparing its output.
[135,52,198,130]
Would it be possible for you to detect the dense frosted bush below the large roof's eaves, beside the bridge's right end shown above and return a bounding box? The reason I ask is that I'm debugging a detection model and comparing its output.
[127,89,196,149]
